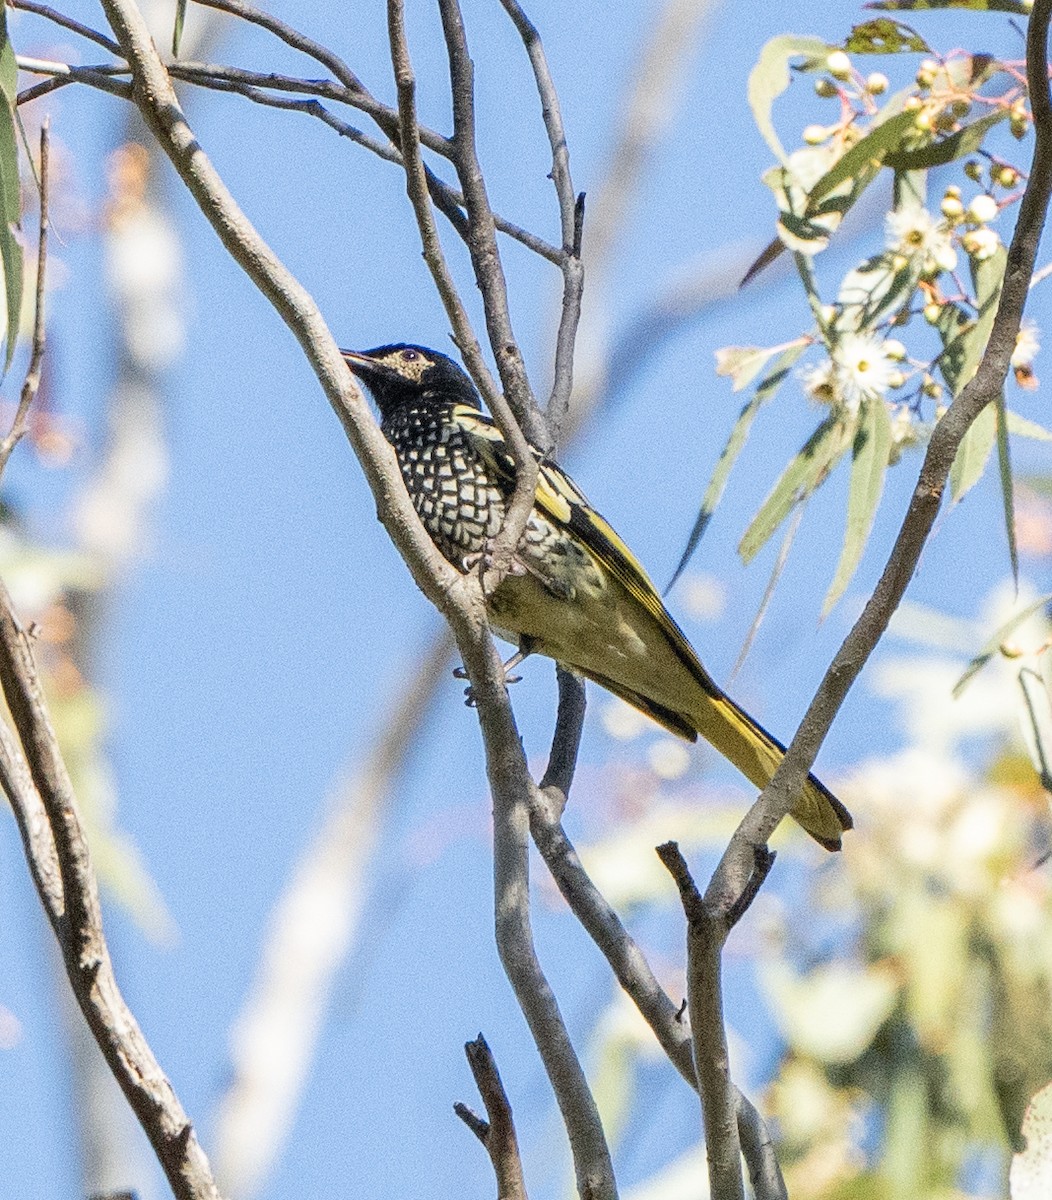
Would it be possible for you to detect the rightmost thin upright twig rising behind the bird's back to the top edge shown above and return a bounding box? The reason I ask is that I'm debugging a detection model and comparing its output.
[500,0,584,432]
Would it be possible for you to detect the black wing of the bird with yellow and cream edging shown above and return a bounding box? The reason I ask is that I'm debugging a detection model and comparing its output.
[453,404,722,696]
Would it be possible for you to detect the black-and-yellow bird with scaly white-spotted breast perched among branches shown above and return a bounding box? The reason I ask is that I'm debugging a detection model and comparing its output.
[341,342,852,850]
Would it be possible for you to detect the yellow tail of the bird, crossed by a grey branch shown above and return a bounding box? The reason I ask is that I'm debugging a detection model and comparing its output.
[691,692,853,850]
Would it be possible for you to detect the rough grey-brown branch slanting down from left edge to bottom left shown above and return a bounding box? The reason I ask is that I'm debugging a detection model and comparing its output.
[0,583,220,1200]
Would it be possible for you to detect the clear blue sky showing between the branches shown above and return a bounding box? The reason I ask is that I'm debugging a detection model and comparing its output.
[0,0,1047,1200]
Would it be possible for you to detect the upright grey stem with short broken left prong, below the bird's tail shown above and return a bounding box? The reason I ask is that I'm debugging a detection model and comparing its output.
[657,841,745,1200]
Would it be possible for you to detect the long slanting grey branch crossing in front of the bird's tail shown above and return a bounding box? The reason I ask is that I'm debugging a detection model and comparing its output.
[705,0,1052,913]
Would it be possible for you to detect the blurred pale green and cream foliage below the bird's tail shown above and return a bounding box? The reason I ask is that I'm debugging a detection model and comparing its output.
[582,564,1052,1200]
